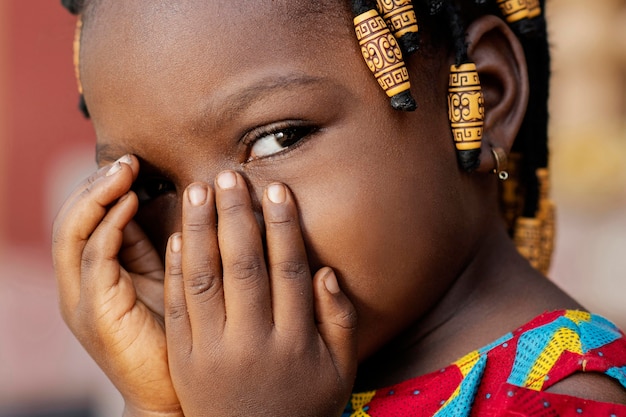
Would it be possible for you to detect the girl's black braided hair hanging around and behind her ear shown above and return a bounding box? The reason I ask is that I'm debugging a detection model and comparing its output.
[61,0,554,272]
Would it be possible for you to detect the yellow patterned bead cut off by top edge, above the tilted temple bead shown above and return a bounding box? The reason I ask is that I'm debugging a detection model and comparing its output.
[376,0,419,54]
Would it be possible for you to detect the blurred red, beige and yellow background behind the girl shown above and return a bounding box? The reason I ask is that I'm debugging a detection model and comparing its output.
[0,0,626,417]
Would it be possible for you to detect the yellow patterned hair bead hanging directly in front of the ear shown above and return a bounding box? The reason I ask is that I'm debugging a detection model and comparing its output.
[448,62,485,171]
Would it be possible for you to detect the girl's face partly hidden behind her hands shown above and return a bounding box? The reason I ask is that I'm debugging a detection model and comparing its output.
[81,0,475,358]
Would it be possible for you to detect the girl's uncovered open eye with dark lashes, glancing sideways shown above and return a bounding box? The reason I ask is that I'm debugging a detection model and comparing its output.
[243,121,319,163]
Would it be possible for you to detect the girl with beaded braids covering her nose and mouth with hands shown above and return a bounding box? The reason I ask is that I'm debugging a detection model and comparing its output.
[53,0,626,417]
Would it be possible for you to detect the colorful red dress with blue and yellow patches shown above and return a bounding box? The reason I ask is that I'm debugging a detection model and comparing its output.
[343,310,626,417]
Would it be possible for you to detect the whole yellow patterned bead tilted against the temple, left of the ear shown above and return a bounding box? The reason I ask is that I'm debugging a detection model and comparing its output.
[354,9,417,111]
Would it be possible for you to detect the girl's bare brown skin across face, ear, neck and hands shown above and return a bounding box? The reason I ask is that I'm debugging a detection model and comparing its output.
[53,0,626,417]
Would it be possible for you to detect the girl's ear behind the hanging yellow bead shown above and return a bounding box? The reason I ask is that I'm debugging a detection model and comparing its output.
[466,15,529,172]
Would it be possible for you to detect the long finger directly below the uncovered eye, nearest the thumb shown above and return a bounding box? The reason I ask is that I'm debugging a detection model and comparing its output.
[263,184,315,333]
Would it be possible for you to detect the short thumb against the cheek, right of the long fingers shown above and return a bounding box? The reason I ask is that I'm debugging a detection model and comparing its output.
[313,268,357,378]
